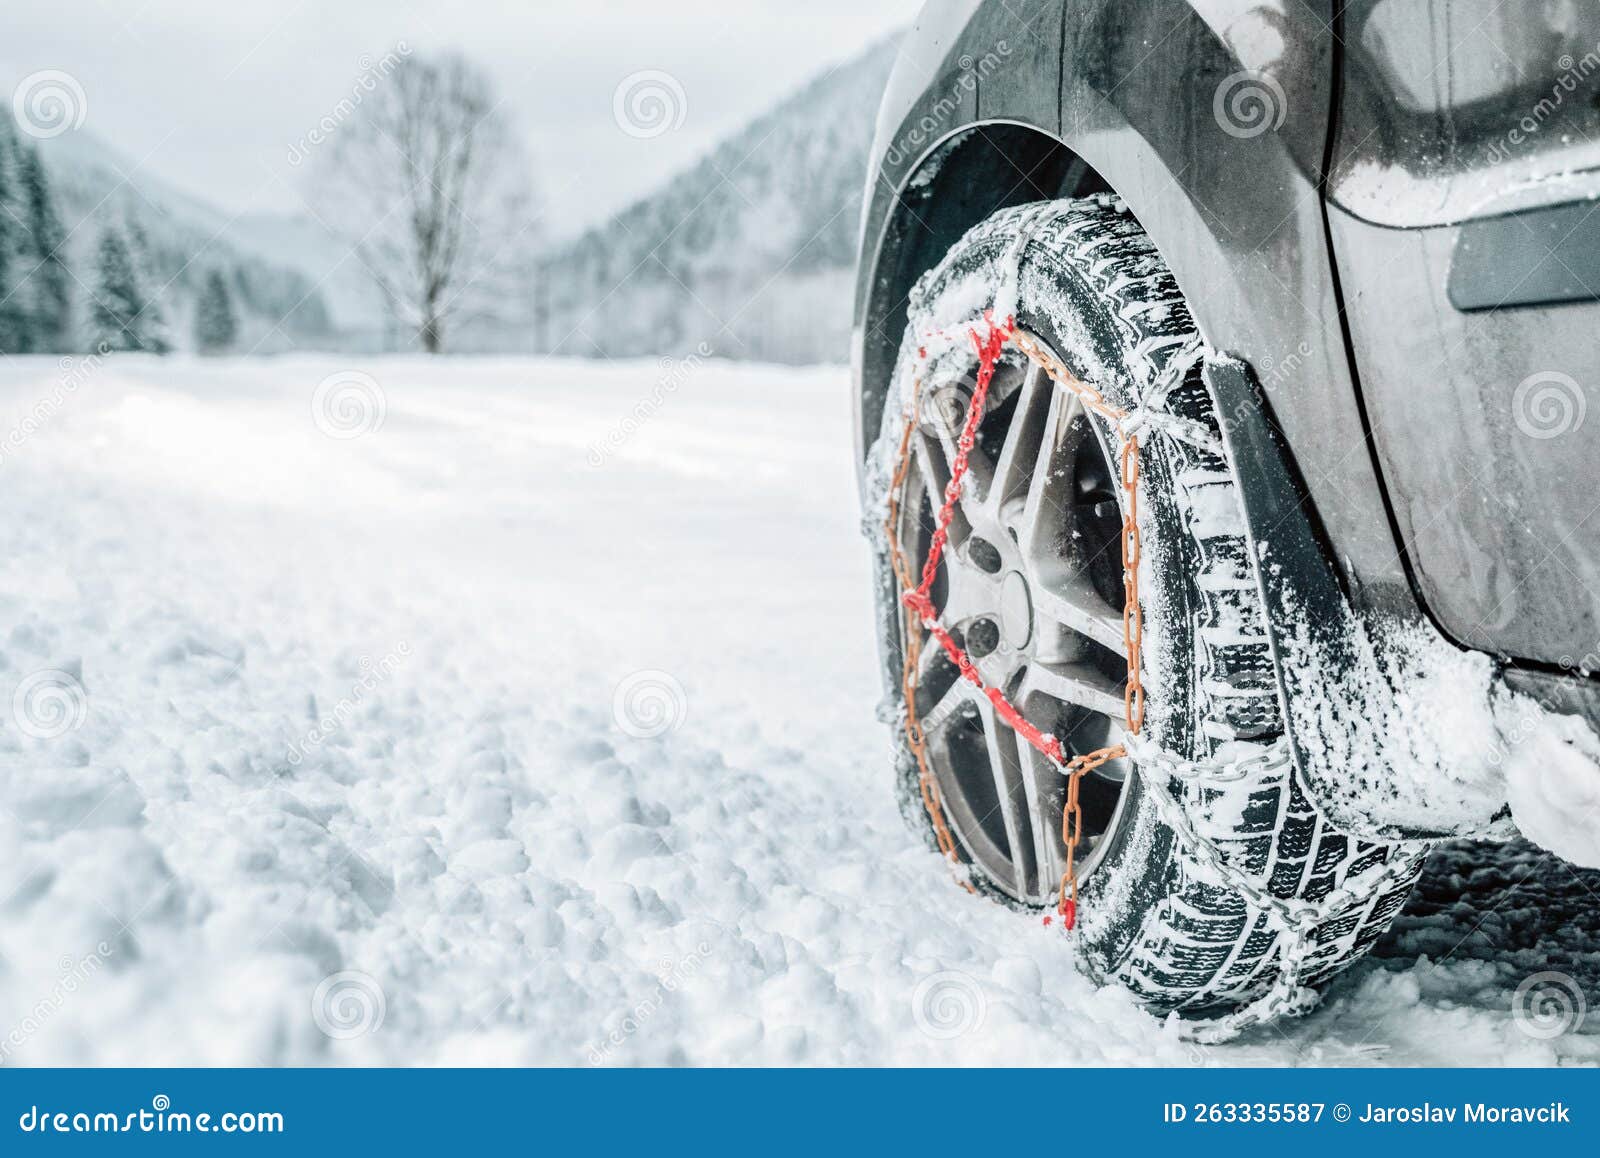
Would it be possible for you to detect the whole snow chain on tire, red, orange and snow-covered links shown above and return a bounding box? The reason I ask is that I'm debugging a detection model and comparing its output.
[886,284,1413,1043]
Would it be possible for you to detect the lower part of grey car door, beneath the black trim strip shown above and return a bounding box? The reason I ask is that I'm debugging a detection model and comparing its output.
[1324,213,1600,665]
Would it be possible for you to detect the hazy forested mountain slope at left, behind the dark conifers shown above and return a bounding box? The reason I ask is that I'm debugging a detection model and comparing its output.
[34,120,336,353]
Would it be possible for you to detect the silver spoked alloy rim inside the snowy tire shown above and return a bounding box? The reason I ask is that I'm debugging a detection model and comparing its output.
[896,339,1130,905]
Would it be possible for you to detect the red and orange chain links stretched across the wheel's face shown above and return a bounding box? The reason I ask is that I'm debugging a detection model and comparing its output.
[886,310,1144,931]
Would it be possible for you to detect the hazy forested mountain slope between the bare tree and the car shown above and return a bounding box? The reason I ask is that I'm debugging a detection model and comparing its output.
[534,42,894,363]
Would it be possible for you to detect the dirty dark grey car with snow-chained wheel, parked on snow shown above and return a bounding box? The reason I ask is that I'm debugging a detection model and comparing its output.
[853,0,1600,1040]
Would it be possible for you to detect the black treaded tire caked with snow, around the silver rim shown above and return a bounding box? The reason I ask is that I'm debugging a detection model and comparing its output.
[867,197,1426,1027]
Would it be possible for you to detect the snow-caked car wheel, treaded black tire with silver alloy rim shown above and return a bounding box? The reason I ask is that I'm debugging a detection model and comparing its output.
[869,197,1426,1036]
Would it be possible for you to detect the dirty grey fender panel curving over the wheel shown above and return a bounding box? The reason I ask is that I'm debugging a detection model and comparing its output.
[851,0,1416,614]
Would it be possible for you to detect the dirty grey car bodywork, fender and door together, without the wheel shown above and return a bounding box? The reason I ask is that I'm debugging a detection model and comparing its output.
[854,0,1600,837]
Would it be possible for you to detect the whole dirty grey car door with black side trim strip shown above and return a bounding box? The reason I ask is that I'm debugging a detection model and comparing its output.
[1324,0,1600,665]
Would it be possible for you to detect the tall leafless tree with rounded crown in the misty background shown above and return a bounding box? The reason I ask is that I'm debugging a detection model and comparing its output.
[312,54,534,353]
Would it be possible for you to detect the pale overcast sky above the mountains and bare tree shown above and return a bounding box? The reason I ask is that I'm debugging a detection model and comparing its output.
[0,0,920,234]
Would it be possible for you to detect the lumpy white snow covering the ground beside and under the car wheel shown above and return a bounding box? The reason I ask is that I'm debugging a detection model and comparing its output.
[0,358,1600,1065]
